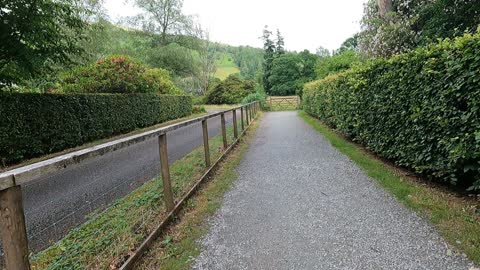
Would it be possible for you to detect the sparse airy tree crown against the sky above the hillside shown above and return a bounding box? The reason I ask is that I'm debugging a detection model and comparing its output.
[133,0,191,45]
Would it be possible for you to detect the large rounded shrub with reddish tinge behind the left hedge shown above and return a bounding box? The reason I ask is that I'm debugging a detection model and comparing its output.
[61,56,181,94]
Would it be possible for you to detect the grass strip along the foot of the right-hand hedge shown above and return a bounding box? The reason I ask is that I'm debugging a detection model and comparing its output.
[299,111,480,264]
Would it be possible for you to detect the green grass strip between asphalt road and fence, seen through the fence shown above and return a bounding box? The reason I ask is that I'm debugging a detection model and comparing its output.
[31,123,240,269]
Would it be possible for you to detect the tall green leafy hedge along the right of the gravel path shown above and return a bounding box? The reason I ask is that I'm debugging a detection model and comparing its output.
[303,34,480,191]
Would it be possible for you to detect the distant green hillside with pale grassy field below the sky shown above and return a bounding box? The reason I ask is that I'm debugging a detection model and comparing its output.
[84,21,263,91]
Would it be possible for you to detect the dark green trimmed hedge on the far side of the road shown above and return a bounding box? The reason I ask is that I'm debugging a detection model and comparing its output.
[0,93,192,165]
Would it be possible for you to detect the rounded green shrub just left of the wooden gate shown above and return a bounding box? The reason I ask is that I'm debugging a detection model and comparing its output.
[206,75,255,104]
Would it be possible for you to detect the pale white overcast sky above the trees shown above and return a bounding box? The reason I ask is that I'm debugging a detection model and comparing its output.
[105,0,366,52]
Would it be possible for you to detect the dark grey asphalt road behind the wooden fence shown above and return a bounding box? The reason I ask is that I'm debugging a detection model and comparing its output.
[22,109,240,250]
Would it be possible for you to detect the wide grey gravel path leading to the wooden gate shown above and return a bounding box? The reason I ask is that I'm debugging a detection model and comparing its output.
[193,112,472,270]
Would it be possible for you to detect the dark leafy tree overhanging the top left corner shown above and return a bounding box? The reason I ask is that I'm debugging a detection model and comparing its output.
[0,0,87,88]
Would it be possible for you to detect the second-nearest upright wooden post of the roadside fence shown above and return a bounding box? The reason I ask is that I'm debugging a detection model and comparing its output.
[158,134,175,212]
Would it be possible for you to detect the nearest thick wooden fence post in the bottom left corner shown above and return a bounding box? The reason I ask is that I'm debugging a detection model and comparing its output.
[0,186,30,270]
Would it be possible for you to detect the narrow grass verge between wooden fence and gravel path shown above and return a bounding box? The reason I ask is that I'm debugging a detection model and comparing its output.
[136,113,258,270]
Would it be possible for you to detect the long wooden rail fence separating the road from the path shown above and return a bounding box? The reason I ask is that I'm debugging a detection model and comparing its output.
[0,102,260,270]
